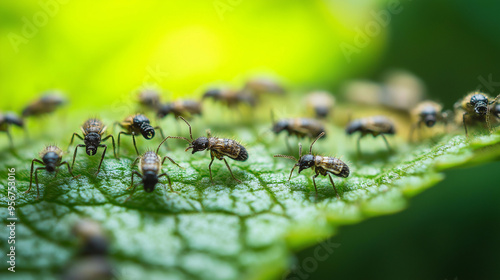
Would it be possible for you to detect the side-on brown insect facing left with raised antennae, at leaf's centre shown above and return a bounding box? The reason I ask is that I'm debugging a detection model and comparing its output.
[165,117,248,183]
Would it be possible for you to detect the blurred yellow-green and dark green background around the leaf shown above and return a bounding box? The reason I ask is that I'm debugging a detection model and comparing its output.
[0,0,500,279]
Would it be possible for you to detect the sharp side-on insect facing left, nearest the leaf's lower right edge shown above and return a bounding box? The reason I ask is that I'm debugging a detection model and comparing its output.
[274,132,349,199]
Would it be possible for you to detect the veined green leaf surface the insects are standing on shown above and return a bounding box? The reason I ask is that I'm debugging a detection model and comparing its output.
[0,112,500,279]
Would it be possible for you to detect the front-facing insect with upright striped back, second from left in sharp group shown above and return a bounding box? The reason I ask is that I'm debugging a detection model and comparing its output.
[69,118,116,175]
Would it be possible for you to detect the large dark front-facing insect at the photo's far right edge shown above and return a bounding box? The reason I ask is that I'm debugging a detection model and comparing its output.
[455,91,500,137]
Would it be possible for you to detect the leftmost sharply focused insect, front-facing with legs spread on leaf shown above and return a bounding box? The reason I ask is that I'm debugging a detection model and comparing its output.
[25,145,75,199]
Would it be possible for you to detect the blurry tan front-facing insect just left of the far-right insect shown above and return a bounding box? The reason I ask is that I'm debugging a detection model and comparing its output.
[409,100,447,141]
